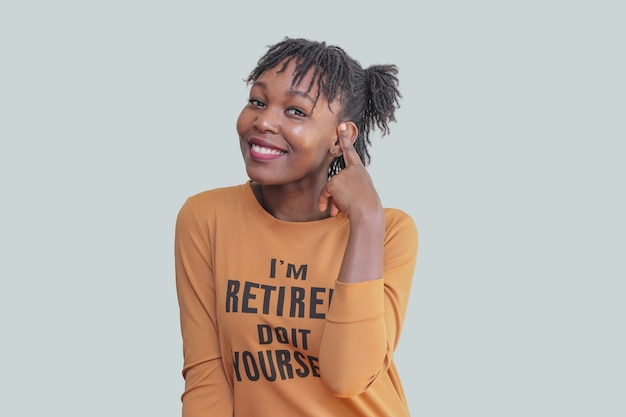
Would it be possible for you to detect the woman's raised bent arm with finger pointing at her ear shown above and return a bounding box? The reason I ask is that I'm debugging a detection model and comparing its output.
[319,125,417,397]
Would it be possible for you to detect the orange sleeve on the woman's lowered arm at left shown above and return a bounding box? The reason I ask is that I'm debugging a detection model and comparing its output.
[175,200,233,417]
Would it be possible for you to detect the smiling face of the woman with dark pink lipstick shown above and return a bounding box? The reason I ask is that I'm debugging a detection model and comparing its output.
[237,62,338,188]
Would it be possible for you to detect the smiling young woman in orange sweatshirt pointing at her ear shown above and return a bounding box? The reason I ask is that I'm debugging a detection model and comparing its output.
[175,38,417,417]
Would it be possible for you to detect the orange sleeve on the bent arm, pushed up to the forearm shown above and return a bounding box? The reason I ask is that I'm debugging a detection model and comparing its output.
[319,208,418,397]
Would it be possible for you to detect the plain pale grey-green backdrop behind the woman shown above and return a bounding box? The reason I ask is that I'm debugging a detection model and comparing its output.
[0,0,626,417]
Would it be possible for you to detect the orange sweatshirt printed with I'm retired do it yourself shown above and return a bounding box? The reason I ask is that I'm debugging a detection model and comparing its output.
[175,182,417,417]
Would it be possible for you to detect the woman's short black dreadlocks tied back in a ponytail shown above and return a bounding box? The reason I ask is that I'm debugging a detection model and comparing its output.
[245,37,401,178]
